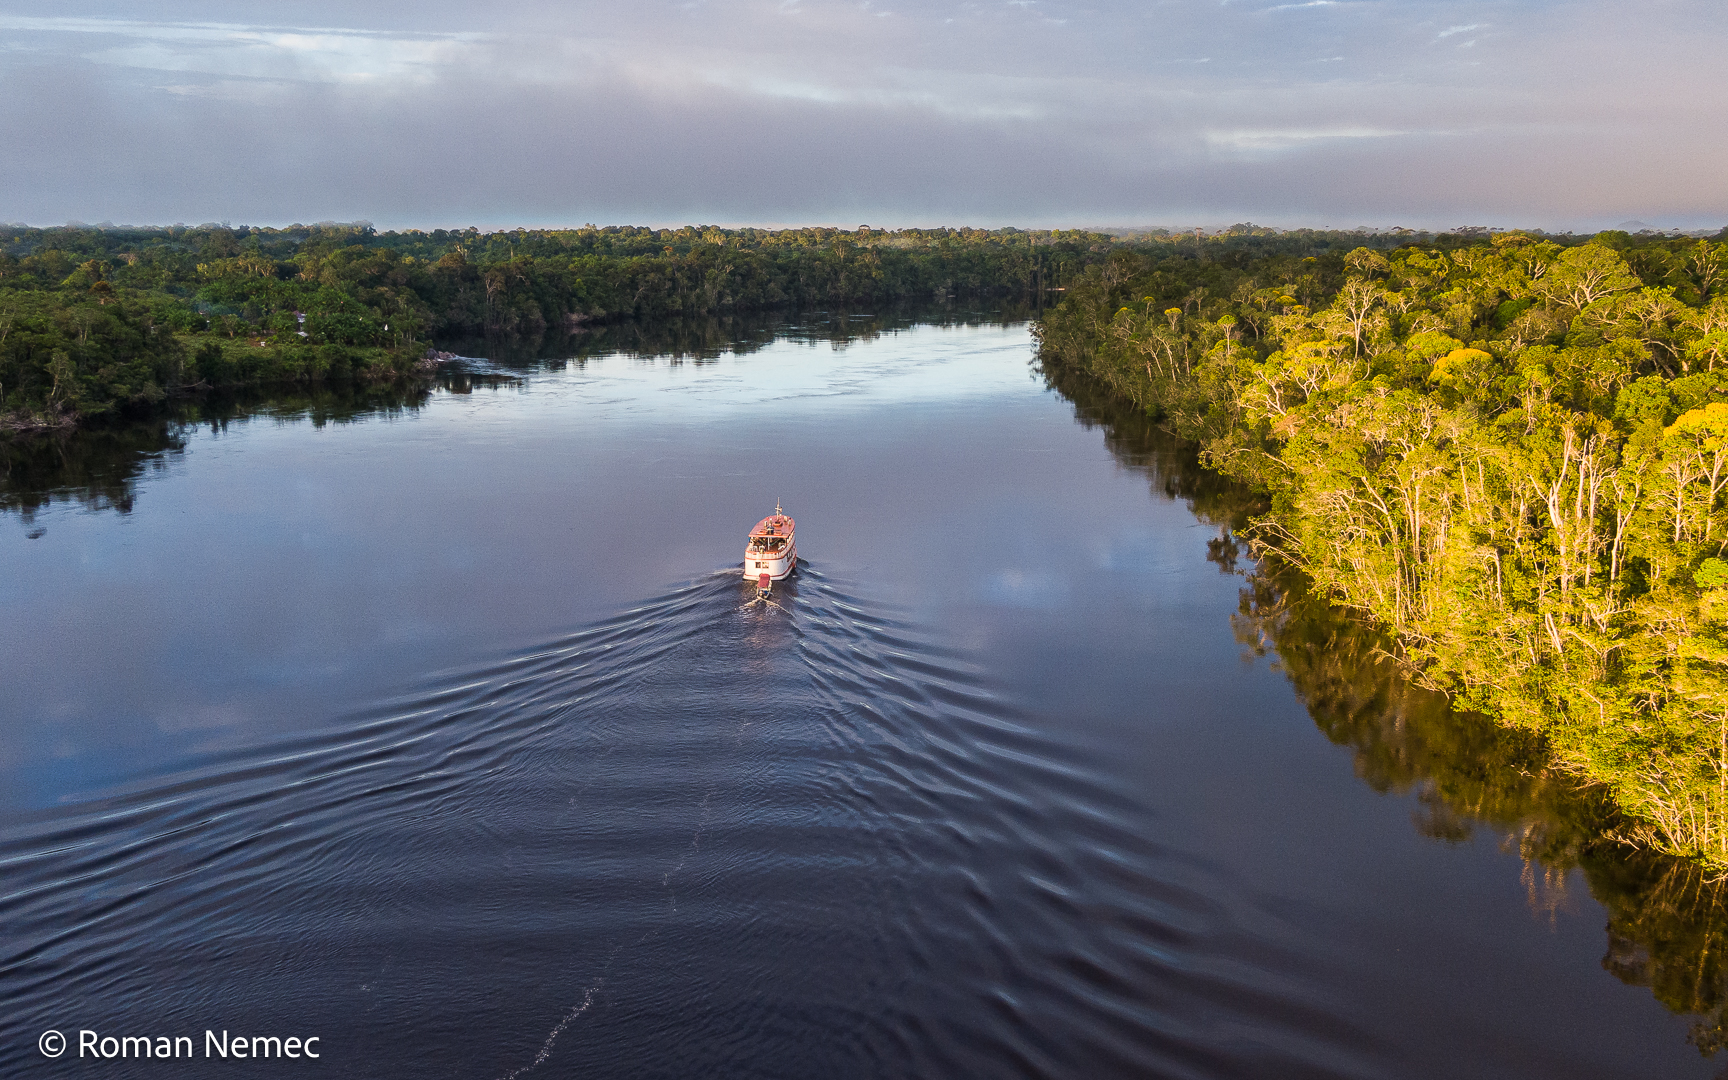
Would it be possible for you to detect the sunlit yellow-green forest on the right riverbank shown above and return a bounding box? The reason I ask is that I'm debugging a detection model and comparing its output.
[1037,230,1728,874]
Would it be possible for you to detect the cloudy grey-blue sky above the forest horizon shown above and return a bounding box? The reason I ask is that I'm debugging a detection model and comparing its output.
[0,0,1728,232]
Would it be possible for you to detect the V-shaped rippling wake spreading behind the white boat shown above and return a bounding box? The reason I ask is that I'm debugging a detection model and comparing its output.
[0,567,1375,1080]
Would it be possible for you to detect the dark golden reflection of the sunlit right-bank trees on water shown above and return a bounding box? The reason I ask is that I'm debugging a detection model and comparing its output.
[1045,355,1728,1075]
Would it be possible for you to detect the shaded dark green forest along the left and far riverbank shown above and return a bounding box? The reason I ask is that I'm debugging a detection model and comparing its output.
[0,223,1472,427]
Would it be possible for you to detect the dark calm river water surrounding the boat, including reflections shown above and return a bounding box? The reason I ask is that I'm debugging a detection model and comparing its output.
[0,316,1725,1080]
